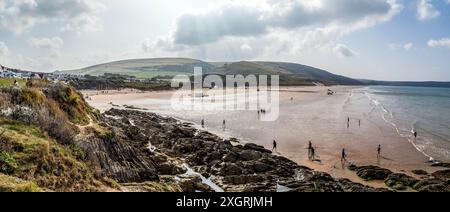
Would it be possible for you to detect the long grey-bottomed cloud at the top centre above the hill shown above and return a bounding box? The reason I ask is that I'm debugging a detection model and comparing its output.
[173,0,399,45]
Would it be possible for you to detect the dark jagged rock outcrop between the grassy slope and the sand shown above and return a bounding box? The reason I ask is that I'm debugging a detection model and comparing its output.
[96,109,386,192]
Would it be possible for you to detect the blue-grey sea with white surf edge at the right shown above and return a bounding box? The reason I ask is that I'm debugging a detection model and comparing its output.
[359,86,450,161]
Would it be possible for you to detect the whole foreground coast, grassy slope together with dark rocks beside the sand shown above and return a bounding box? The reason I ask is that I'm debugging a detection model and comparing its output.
[0,81,450,192]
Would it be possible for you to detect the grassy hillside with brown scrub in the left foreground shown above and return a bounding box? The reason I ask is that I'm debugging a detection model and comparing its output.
[0,81,107,191]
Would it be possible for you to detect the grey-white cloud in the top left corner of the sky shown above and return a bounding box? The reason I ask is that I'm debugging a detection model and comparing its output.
[0,0,105,33]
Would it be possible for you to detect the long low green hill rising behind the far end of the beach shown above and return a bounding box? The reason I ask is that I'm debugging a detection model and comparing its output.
[64,58,362,85]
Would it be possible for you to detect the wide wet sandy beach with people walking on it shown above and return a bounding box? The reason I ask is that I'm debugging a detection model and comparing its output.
[83,86,442,187]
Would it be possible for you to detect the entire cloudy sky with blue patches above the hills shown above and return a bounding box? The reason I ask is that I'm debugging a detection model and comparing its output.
[0,0,450,81]
